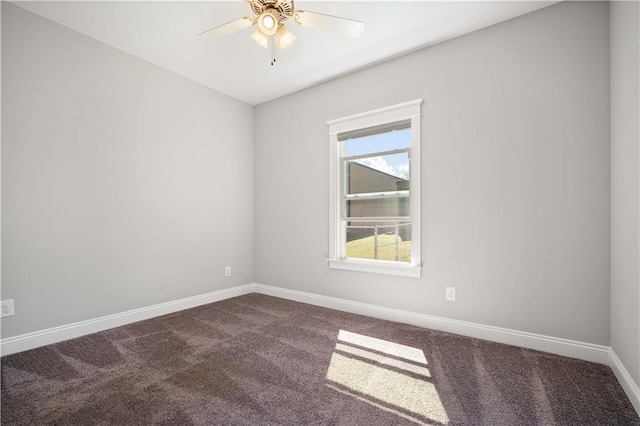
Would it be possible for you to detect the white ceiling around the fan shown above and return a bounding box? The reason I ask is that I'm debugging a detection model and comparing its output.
[13,0,557,105]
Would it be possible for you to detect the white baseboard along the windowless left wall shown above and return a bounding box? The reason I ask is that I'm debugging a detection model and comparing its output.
[0,284,254,356]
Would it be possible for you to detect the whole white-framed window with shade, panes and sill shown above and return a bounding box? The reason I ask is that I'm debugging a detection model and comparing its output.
[327,99,422,277]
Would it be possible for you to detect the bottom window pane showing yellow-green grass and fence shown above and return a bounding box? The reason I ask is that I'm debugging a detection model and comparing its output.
[346,221,411,262]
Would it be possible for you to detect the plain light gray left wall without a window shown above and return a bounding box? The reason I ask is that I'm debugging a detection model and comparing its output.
[2,2,254,338]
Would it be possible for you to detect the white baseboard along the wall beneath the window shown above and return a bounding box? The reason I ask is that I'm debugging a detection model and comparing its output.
[254,284,609,364]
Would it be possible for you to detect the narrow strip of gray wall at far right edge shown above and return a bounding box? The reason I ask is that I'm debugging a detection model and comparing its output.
[610,1,640,386]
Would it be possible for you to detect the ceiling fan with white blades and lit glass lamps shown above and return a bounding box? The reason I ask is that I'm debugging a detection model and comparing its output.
[198,0,364,65]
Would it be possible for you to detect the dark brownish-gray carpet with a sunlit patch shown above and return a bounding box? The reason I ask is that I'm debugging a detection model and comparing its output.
[1,294,640,425]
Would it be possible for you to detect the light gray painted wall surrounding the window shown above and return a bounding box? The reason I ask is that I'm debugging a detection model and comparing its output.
[254,2,610,345]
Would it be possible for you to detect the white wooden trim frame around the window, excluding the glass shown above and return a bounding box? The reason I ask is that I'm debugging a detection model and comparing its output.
[327,99,422,278]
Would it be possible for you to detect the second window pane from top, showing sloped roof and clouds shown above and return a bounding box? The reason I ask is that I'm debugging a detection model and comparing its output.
[345,152,409,194]
